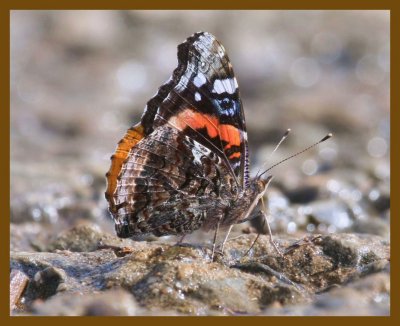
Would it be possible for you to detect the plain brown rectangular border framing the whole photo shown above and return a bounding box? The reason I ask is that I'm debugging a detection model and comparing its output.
[0,0,400,325]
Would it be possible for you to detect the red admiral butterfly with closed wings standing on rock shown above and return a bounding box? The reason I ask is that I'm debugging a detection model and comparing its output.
[105,32,330,258]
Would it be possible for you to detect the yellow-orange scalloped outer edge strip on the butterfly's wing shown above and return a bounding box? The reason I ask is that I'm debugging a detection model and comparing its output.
[106,124,144,210]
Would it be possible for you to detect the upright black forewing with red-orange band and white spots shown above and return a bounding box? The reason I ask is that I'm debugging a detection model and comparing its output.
[142,33,248,185]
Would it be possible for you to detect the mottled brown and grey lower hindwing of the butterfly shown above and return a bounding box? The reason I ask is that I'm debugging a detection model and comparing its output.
[113,125,238,237]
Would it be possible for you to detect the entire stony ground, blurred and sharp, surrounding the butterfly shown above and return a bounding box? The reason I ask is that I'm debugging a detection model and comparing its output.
[10,11,390,315]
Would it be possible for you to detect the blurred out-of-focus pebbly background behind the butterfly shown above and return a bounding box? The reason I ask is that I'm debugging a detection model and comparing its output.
[11,10,390,250]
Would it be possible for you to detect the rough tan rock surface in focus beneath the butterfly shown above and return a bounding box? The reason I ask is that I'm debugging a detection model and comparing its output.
[11,225,389,315]
